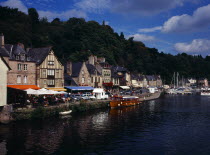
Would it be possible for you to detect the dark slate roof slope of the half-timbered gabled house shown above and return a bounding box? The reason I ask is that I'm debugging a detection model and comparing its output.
[28,47,52,64]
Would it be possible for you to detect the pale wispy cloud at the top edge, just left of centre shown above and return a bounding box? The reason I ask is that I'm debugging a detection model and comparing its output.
[75,0,111,13]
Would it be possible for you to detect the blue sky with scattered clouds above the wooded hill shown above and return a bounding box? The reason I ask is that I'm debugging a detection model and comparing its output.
[0,0,210,56]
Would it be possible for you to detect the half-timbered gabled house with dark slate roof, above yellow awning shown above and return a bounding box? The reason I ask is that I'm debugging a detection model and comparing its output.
[27,47,64,90]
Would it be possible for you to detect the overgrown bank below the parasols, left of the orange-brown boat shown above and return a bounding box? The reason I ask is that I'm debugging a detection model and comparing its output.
[12,101,109,121]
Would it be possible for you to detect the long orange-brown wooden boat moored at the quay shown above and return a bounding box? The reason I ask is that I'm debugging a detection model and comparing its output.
[110,96,140,108]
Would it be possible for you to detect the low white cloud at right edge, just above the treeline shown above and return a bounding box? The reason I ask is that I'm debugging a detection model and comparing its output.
[174,39,210,53]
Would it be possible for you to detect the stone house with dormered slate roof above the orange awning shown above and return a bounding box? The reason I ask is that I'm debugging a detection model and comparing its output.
[0,35,36,85]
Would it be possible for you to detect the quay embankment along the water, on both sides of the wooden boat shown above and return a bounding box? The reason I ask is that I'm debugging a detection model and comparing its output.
[0,92,161,122]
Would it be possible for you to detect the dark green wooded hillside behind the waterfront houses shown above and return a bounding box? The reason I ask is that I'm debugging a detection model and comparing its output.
[0,7,210,83]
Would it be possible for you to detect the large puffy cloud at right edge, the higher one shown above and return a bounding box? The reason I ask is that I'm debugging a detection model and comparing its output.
[162,4,210,32]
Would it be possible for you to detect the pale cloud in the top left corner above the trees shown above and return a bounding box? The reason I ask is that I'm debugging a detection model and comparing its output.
[0,0,28,13]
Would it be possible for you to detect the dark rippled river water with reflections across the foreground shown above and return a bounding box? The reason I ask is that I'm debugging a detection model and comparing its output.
[0,95,210,155]
